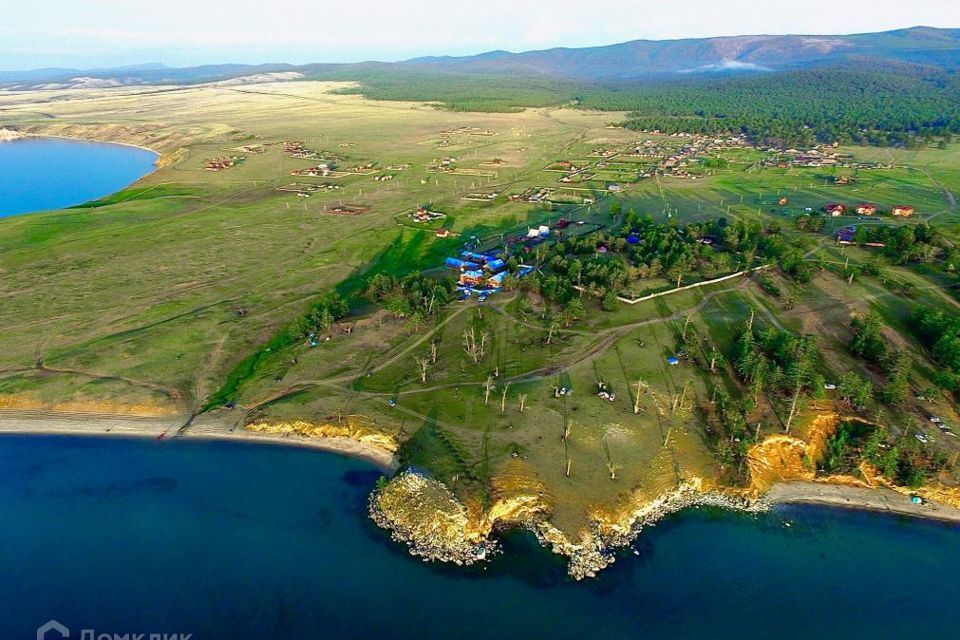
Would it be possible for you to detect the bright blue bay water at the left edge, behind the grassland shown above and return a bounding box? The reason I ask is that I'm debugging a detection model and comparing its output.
[0,138,157,218]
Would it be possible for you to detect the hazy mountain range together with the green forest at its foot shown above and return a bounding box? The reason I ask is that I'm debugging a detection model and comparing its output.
[7,27,960,146]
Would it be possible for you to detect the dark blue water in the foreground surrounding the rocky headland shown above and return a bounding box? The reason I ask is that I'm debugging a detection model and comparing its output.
[0,436,960,640]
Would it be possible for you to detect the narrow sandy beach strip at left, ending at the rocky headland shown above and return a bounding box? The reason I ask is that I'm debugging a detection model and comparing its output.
[0,409,400,474]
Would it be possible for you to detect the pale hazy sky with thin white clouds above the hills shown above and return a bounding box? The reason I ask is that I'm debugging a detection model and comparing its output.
[0,0,960,69]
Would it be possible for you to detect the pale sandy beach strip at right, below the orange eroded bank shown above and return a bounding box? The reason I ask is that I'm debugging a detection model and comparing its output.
[766,482,960,523]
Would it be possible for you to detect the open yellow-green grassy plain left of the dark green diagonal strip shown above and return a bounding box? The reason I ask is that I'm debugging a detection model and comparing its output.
[0,84,592,409]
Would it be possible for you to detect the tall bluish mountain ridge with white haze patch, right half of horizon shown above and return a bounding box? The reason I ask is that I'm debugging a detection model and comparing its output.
[403,27,960,80]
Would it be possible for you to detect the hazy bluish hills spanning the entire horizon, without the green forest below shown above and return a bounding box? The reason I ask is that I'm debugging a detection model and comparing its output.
[0,27,960,89]
